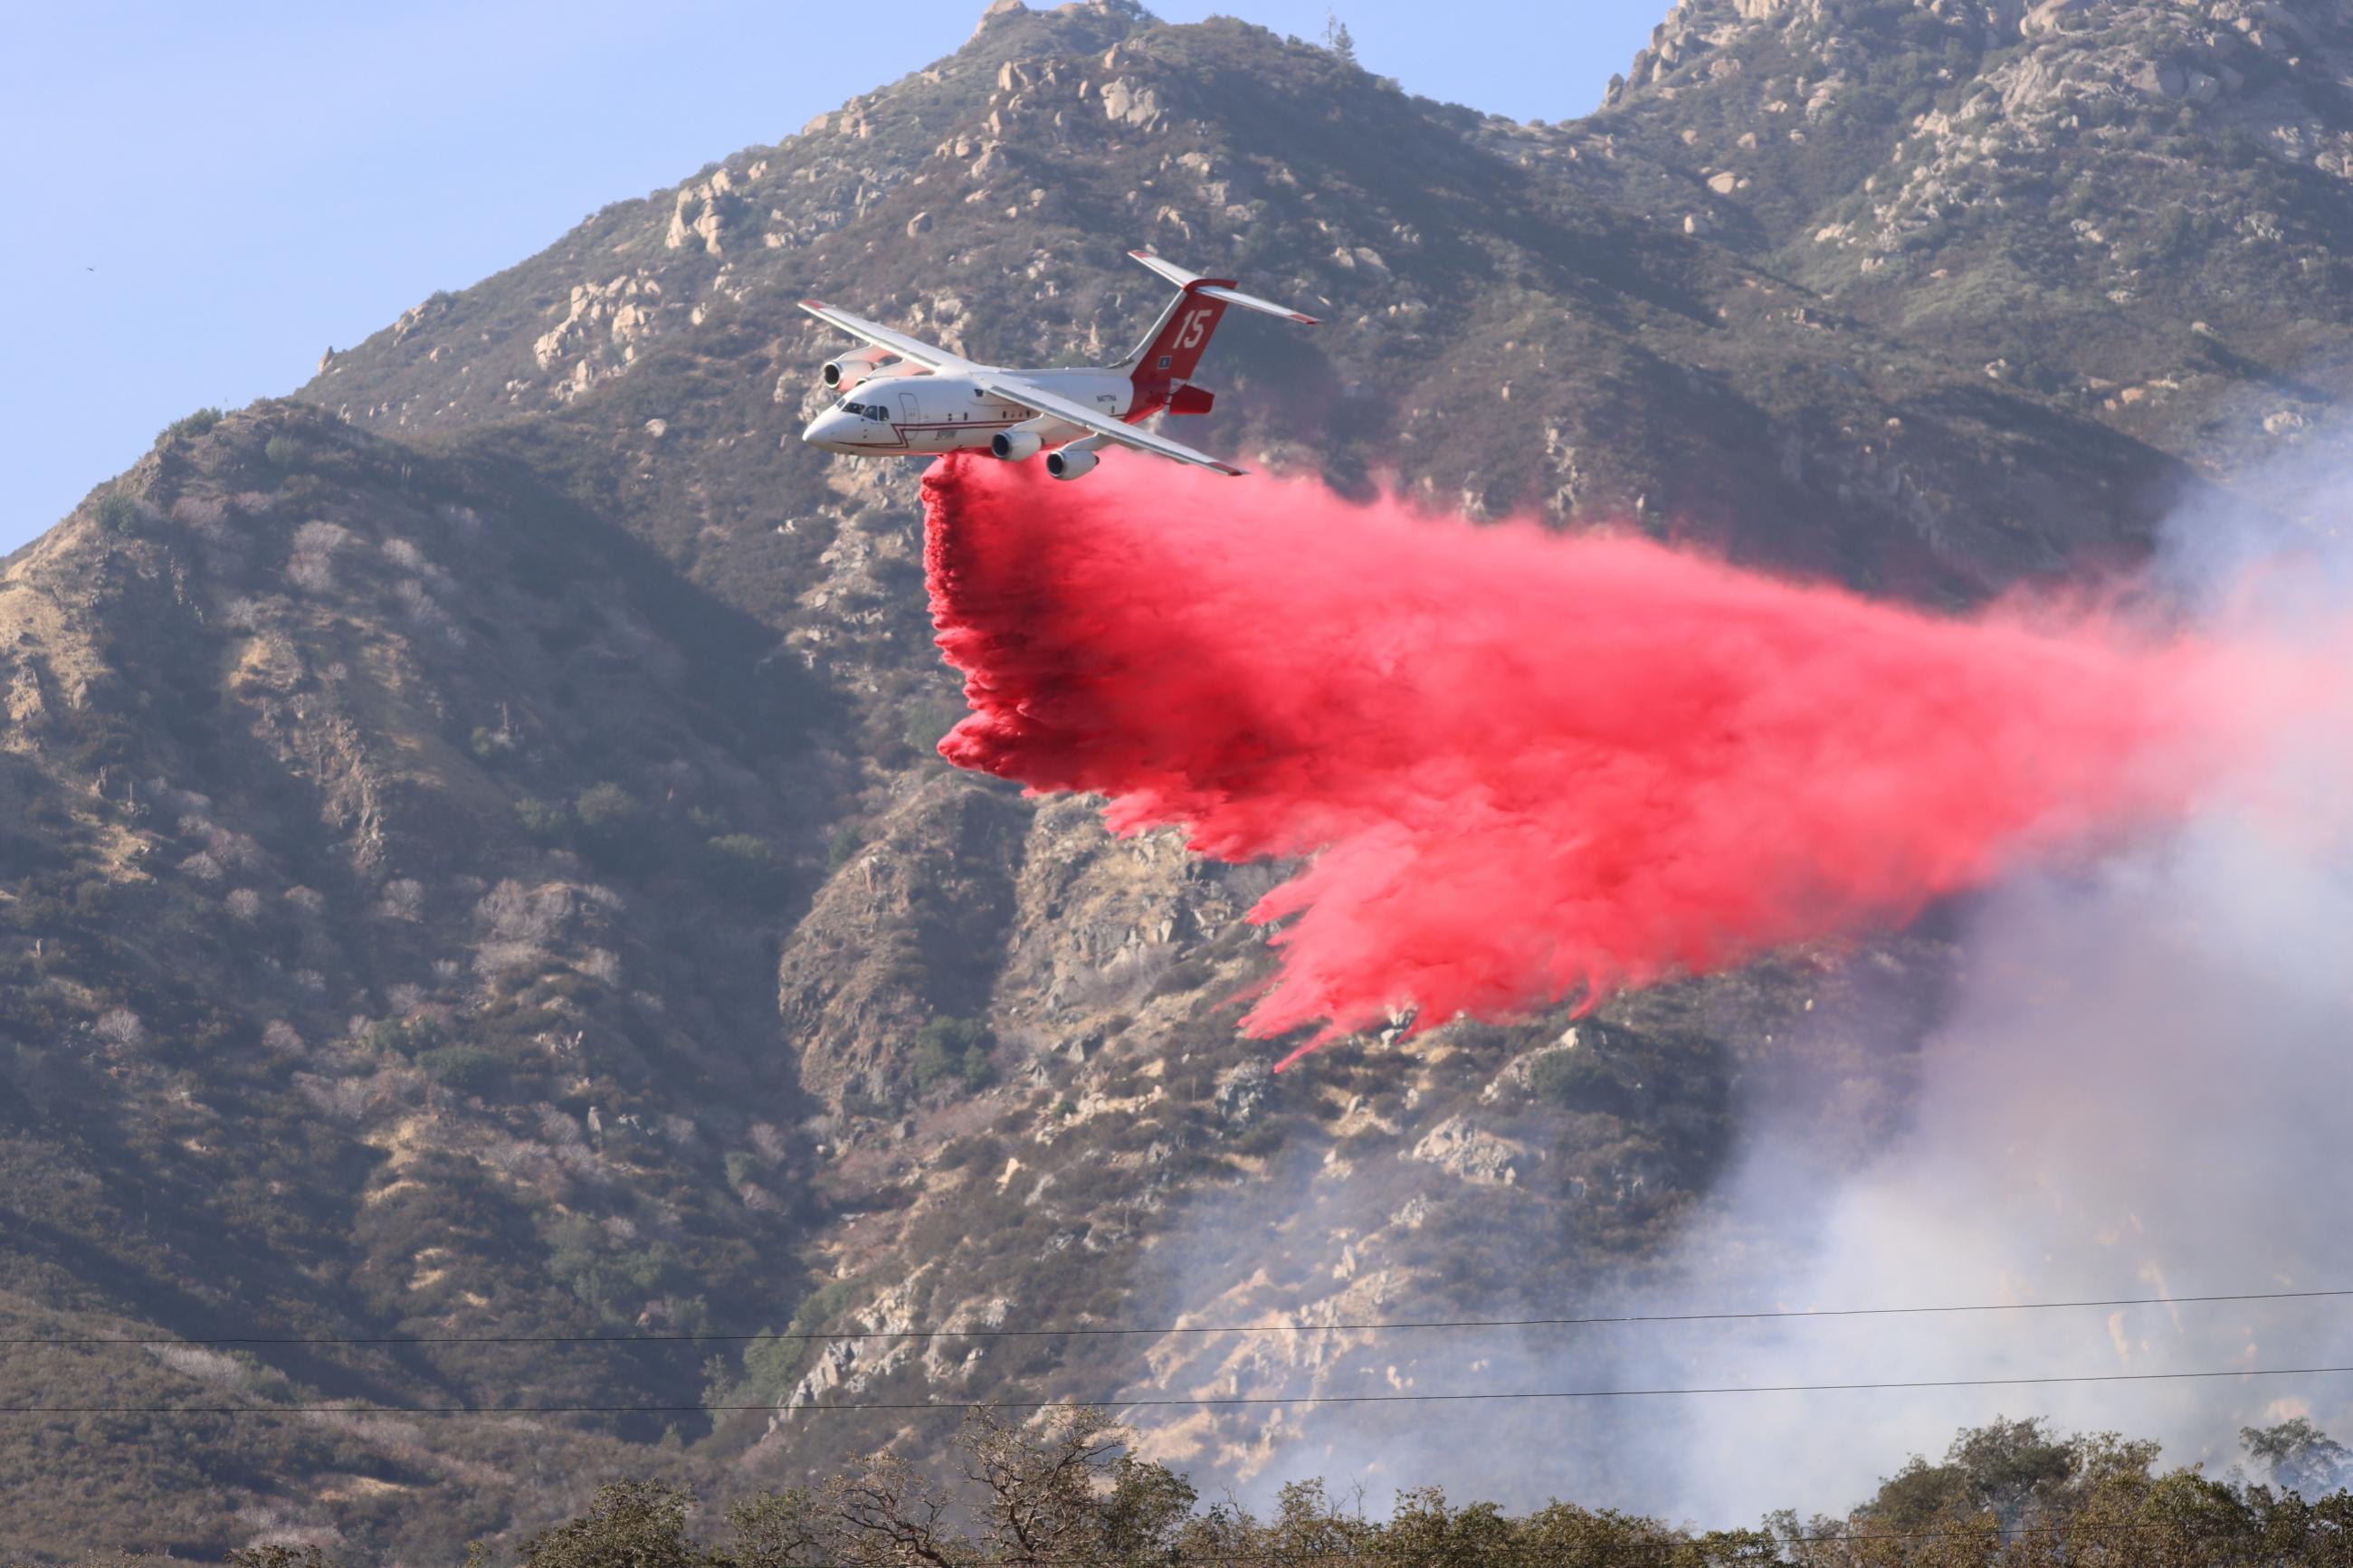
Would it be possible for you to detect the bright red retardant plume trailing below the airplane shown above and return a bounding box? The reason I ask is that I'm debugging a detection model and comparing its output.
[922,459,2209,1065]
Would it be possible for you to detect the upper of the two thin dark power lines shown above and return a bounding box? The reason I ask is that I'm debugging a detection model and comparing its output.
[0,1288,2353,1347]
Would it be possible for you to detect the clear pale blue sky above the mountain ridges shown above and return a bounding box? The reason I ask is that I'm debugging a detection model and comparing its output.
[0,0,1668,550]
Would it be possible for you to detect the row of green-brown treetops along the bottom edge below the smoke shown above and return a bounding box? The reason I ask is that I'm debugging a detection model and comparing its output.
[442,1410,2353,1568]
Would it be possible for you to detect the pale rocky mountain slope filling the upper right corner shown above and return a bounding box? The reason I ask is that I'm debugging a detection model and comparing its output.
[1609,0,2353,465]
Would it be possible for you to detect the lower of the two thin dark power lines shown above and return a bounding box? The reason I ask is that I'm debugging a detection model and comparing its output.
[14,1366,2353,1415]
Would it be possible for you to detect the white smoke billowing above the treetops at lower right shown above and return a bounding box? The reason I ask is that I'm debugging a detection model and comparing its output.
[1115,446,2353,1525]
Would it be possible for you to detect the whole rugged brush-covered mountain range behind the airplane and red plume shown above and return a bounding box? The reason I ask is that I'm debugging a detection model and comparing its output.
[0,0,2353,1561]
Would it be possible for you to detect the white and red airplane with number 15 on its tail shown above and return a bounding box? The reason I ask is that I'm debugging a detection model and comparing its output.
[800,252,1320,480]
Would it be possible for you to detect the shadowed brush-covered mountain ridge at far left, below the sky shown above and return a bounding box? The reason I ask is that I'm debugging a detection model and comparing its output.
[0,406,861,1552]
